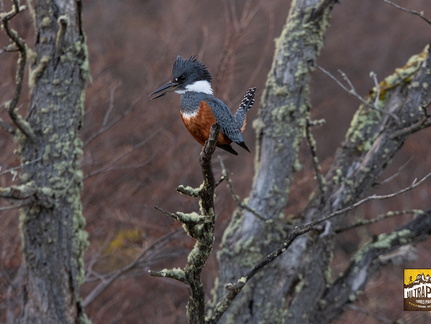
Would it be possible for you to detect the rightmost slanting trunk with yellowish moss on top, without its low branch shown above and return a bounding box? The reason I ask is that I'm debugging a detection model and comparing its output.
[288,46,431,323]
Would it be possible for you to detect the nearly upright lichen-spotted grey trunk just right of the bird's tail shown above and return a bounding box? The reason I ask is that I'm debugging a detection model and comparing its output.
[211,0,331,323]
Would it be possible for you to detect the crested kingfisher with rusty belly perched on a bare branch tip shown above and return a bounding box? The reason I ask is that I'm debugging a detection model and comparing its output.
[149,55,256,155]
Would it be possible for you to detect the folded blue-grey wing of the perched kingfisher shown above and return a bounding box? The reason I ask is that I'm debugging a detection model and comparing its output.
[204,96,244,143]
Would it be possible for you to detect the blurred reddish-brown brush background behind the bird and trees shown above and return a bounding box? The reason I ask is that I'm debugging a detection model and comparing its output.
[0,0,431,323]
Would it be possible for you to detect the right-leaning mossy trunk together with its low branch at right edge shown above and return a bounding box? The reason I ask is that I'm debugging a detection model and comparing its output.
[298,46,431,323]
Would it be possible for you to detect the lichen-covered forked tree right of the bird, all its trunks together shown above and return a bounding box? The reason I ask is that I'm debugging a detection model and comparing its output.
[213,1,431,323]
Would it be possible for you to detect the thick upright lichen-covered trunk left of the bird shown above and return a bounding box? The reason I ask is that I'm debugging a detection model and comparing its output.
[17,0,88,324]
